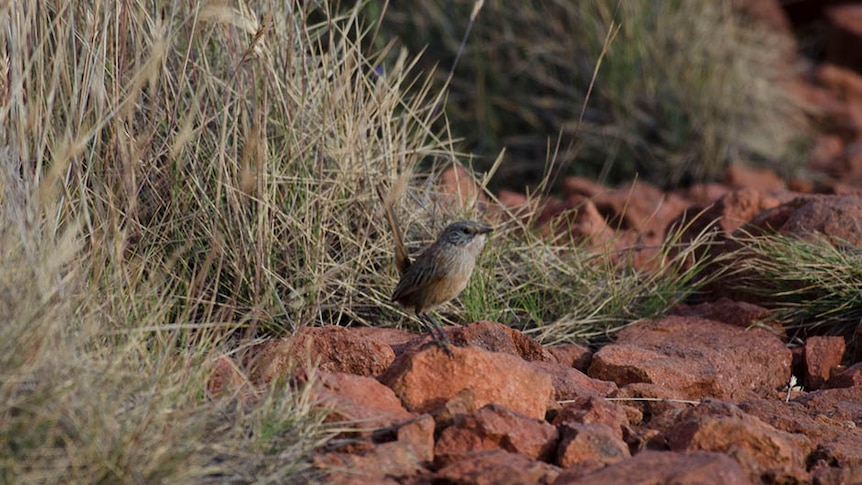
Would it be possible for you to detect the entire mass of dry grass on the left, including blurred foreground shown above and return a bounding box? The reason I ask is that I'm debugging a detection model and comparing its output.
[0,0,438,483]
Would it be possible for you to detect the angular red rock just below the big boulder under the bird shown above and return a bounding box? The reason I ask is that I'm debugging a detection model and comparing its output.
[434,404,557,464]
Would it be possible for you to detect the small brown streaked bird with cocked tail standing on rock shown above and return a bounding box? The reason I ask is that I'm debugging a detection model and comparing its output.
[381,185,493,355]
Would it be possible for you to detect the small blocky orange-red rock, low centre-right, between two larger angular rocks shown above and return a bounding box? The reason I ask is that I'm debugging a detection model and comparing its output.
[557,423,631,468]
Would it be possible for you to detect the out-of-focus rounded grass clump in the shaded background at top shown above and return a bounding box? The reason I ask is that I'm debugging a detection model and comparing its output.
[371,0,803,187]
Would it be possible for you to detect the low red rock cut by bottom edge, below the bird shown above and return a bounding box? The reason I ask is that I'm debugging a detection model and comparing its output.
[434,450,559,485]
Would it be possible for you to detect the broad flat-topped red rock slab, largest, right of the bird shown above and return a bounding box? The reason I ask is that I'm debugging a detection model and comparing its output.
[588,316,792,400]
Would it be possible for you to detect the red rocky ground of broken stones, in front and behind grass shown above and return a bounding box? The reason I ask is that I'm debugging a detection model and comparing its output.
[212,2,862,485]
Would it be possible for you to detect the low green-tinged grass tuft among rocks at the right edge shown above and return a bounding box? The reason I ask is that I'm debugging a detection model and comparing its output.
[728,234,862,332]
